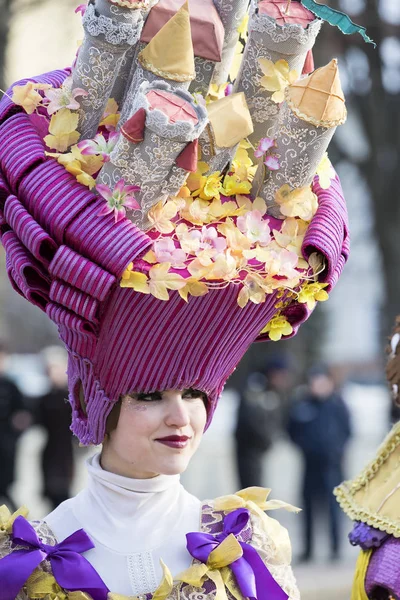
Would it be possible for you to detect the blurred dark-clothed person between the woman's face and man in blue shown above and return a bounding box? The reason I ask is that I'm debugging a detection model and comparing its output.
[235,357,292,488]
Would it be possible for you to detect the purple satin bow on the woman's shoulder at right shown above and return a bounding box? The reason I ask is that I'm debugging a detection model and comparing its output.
[186,508,289,600]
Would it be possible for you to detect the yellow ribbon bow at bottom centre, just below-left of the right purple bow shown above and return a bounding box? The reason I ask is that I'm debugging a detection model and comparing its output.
[177,533,243,600]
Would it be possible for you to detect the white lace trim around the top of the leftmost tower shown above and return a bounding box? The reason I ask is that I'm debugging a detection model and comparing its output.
[82,4,143,46]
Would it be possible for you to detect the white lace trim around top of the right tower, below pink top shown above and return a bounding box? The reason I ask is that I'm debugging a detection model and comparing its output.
[251,14,322,52]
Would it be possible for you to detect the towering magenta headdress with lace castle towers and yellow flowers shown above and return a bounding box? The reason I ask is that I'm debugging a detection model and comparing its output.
[0,0,372,444]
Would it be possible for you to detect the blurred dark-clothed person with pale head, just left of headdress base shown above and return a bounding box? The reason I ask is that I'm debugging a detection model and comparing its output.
[37,346,74,508]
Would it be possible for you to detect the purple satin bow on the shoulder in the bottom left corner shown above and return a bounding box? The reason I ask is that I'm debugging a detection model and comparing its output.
[0,516,109,600]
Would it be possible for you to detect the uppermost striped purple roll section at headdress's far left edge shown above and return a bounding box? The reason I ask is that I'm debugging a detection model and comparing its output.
[0,113,46,193]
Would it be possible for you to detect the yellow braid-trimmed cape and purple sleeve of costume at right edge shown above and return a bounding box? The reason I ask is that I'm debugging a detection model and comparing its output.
[335,423,400,600]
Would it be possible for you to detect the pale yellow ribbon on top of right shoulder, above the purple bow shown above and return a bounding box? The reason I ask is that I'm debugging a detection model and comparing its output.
[214,486,301,512]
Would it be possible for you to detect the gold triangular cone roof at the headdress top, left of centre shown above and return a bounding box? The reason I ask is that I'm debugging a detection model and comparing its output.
[138,1,195,81]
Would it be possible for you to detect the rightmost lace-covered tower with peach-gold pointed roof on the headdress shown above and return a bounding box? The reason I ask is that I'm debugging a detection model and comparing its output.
[252,59,347,217]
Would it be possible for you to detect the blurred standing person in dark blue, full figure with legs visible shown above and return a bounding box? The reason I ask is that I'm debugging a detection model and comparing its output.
[288,365,351,561]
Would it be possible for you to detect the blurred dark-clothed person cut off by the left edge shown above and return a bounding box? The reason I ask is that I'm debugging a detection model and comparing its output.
[0,342,32,509]
